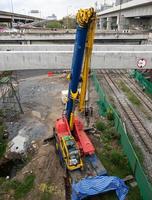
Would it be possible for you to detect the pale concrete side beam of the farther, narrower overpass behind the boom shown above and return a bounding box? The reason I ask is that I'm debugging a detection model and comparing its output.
[0,31,149,42]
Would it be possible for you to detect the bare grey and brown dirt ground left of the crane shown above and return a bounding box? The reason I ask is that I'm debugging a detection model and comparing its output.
[8,74,68,200]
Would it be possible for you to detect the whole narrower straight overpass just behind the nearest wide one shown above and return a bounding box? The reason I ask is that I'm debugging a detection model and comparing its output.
[0,29,150,44]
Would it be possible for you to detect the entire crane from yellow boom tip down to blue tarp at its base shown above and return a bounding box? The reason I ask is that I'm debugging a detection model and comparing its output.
[54,8,128,200]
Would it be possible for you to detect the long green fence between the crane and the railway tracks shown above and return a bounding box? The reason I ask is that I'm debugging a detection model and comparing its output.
[92,73,152,200]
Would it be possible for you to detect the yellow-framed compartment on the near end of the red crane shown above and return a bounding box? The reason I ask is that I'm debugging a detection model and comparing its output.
[61,136,83,171]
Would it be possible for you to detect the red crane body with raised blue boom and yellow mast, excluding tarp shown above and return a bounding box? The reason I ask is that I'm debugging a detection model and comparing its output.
[55,8,96,170]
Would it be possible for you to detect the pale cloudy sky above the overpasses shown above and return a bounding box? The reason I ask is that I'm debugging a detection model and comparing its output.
[0,0,115,19]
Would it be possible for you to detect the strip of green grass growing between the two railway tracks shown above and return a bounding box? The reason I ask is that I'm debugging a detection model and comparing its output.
[118,81,141,106]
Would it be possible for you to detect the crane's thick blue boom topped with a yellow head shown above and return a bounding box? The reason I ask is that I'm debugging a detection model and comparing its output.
[66,8,95,130]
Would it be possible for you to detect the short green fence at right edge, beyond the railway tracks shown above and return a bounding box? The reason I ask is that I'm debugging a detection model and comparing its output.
[132,70,152,94]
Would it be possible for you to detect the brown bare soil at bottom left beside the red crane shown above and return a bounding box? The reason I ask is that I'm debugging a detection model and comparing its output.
[16,142,65,200]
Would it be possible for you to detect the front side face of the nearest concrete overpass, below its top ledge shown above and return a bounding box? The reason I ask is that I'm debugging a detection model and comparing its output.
[0,50,152,71]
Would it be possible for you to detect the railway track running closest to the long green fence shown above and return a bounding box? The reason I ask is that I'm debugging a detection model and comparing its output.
[102,71,152,154]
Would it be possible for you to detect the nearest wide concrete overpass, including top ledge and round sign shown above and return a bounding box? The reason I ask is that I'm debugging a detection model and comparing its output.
[0,45,152,71]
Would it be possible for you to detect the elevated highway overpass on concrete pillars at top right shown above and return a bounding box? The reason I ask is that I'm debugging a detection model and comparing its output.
[98,0,152,30]
